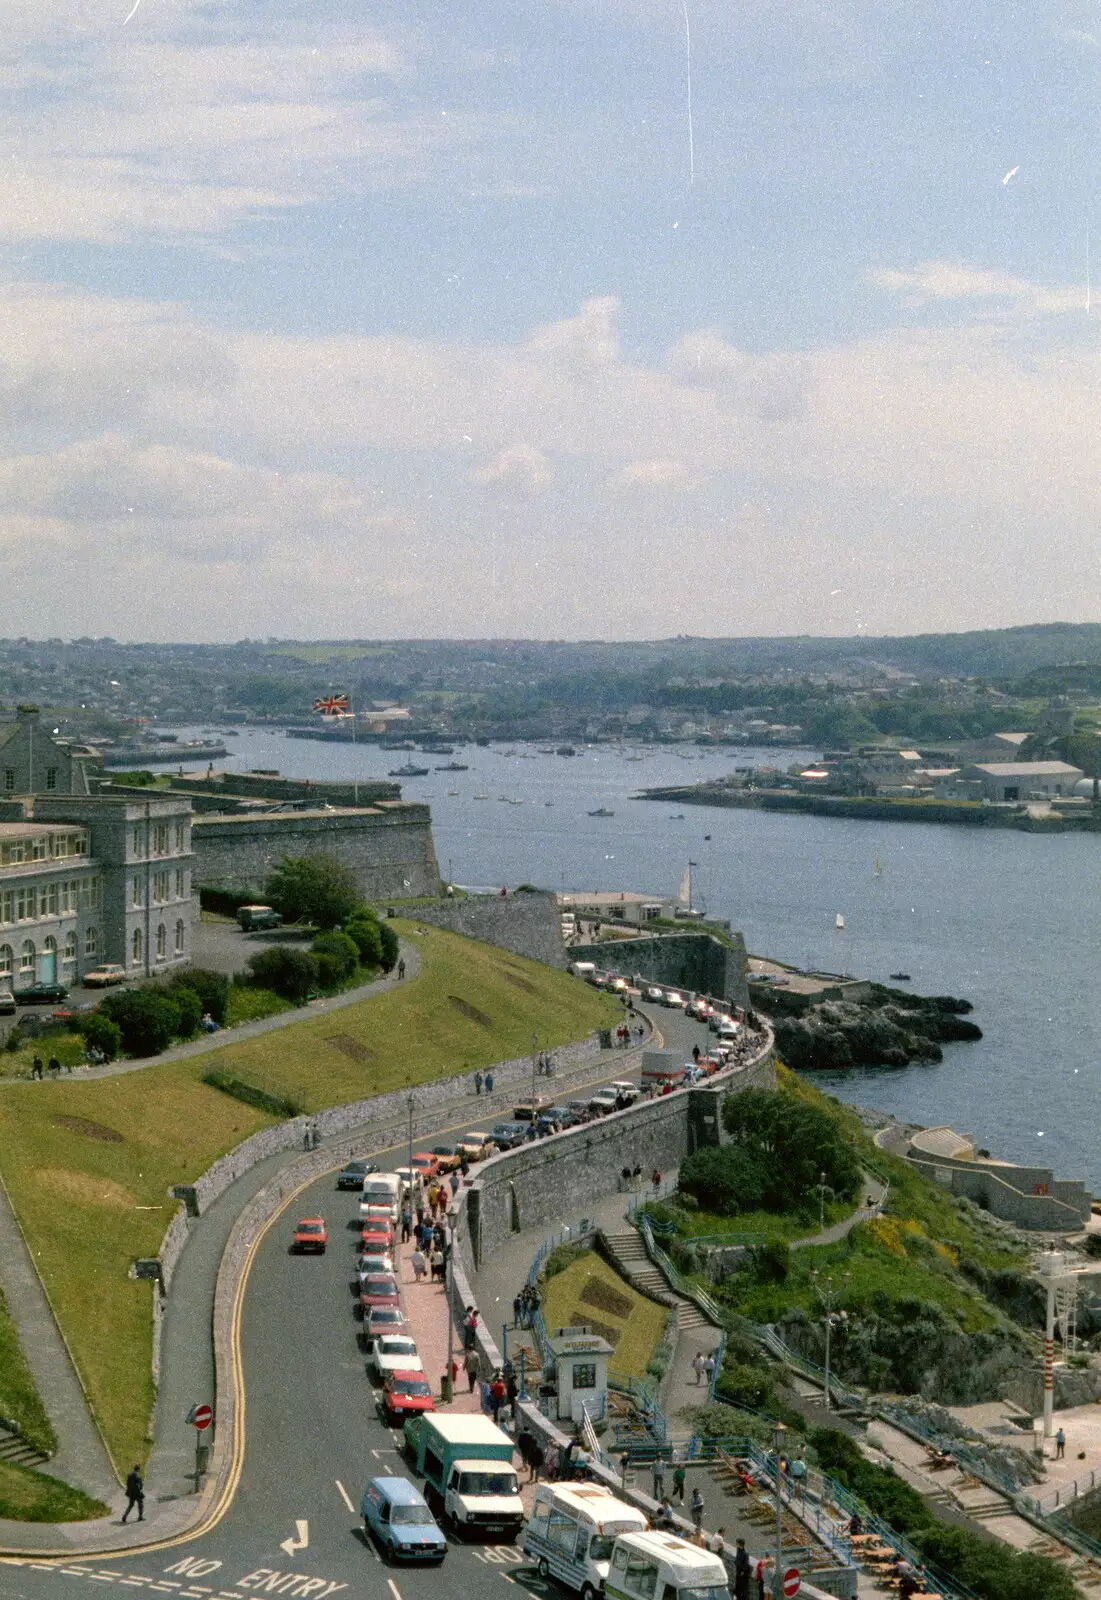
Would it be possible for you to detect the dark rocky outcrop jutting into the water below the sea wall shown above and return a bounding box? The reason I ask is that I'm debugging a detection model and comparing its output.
[757,984,983,1072]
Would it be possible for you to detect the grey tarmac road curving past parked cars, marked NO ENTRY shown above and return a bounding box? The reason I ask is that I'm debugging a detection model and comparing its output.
[0,1011,707,1600]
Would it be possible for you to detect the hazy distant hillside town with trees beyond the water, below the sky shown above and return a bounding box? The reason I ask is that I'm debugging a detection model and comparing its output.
[0,622,1101,746]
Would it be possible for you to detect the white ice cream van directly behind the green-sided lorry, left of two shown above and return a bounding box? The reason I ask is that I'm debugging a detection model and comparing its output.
[522,1483,647,1600]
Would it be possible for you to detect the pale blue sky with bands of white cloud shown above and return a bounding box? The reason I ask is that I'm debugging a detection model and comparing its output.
[0,0,1101,640]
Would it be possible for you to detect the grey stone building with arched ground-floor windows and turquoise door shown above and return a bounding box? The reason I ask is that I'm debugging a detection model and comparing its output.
[0,794,195,989]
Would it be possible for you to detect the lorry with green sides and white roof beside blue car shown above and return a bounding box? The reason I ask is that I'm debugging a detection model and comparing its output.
[405,1413,523,1539]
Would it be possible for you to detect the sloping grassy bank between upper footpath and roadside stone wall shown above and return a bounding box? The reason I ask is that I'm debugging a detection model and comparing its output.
[0,928,619,1462]
